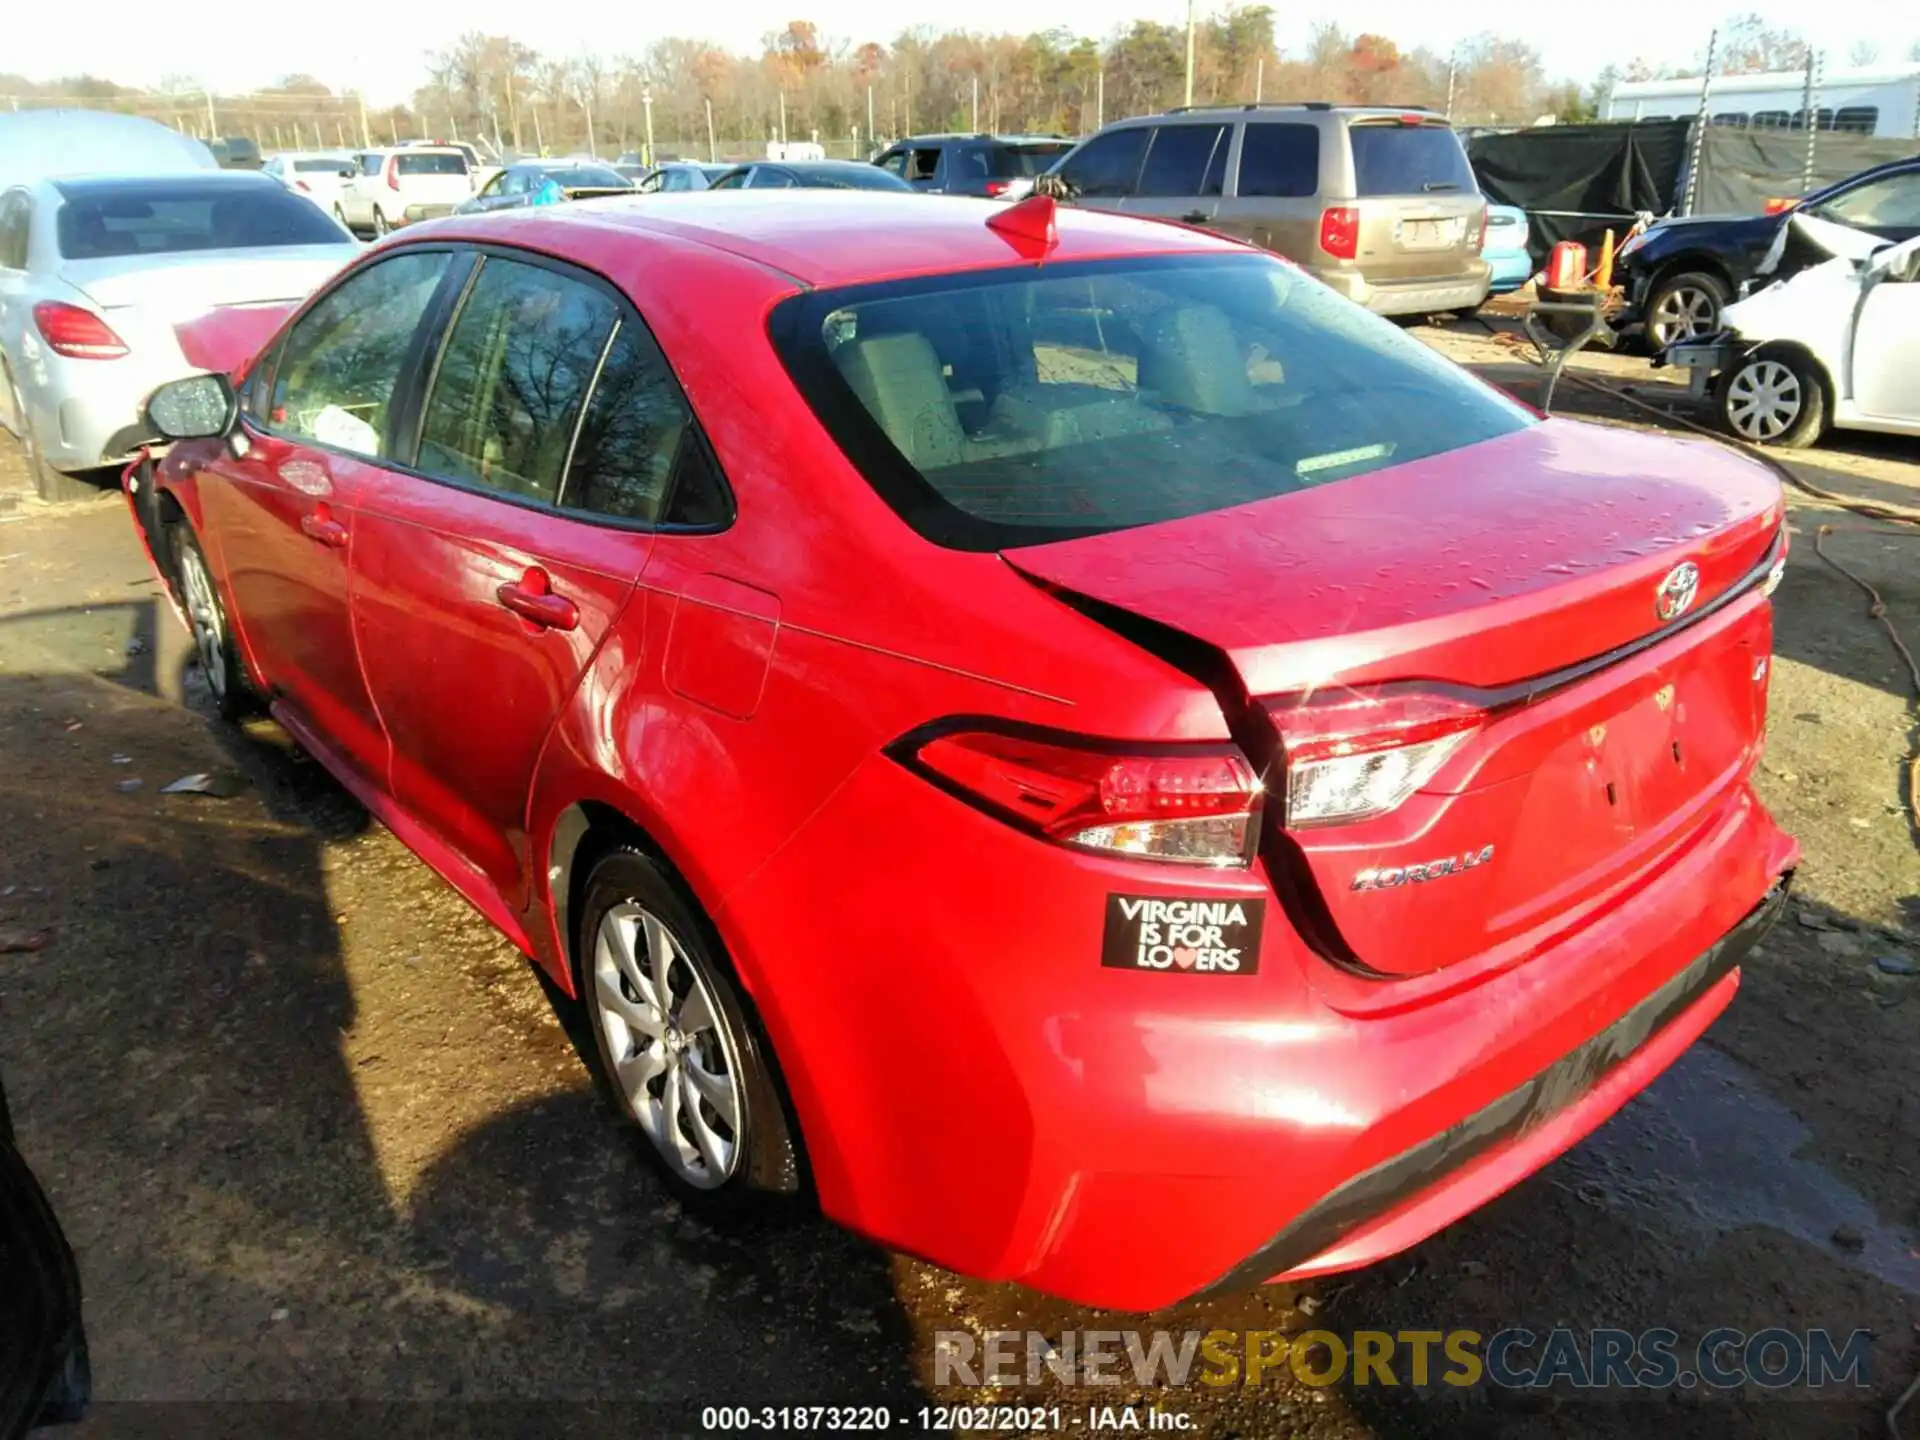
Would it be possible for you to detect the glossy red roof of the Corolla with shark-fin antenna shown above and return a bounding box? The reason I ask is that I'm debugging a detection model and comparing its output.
[409,192,1248,286]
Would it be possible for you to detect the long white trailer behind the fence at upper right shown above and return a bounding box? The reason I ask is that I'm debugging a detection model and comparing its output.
[1603,65,1920,140]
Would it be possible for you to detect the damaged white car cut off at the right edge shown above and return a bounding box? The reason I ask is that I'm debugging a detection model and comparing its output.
[1657,215,1920,447]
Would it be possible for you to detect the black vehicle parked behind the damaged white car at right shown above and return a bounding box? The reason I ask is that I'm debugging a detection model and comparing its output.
[1615,157,1920,349]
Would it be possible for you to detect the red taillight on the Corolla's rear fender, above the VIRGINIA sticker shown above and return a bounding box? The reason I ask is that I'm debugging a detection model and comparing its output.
[897,730,1263,866]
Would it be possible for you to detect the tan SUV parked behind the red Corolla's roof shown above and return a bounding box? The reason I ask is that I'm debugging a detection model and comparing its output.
[1037,102,1488,315]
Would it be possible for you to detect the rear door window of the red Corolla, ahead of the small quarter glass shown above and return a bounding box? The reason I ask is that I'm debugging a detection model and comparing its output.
[419,257,620,503]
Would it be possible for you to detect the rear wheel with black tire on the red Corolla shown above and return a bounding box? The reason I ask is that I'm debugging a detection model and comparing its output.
[572,845,801,1213]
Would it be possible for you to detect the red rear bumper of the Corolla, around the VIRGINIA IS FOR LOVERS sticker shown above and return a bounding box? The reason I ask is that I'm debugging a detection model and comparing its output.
[716,760,1799,1311]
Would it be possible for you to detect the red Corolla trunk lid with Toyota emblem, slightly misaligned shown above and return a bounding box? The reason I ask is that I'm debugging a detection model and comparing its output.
[1008,420,1782,973]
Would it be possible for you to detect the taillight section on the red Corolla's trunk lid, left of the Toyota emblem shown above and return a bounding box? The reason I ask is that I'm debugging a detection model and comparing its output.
[1269,685,1486,829]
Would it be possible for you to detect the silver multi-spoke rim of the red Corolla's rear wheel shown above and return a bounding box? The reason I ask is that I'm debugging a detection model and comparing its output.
[591,900,747,1190]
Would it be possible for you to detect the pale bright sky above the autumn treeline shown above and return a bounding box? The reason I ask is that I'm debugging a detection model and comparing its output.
[11,0,1920,104]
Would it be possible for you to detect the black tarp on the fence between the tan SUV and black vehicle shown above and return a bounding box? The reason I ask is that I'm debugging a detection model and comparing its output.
[1467,121,1693,259]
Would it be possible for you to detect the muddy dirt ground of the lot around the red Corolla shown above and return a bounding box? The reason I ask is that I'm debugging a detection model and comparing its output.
[0,326,1920,1440]
